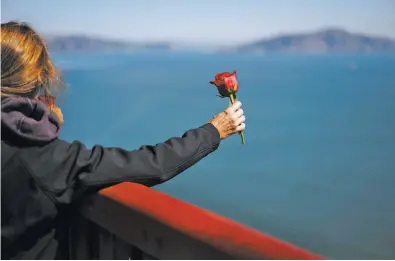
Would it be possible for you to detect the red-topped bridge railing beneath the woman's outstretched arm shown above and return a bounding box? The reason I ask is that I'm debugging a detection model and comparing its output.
[71,183,323,259]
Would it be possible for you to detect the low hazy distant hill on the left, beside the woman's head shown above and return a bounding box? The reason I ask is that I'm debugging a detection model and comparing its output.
[46,35,171,52]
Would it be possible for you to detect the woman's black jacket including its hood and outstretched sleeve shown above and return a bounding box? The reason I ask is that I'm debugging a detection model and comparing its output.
[1,98,220,259]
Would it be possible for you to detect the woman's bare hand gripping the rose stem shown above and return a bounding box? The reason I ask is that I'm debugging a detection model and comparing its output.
[209,101,246,139]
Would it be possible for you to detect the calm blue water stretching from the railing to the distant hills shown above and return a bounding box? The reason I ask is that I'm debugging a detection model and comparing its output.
[55,52,395,259]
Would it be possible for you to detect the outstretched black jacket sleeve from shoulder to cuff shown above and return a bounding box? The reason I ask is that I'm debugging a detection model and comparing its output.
[31,123,220,201]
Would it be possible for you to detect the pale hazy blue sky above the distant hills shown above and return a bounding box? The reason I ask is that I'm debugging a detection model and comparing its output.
[1,0,395,44]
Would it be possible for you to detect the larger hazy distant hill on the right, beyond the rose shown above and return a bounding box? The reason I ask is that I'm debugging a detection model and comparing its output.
[235,29,395,53]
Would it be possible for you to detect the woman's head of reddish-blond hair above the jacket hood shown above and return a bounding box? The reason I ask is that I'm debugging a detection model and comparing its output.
[1,22,62,98]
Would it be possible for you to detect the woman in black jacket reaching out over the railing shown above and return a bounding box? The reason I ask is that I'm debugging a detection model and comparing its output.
[1,22,245,259]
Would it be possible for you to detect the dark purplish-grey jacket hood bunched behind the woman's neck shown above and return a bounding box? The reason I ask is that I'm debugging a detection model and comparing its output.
[1,96,61,143]
